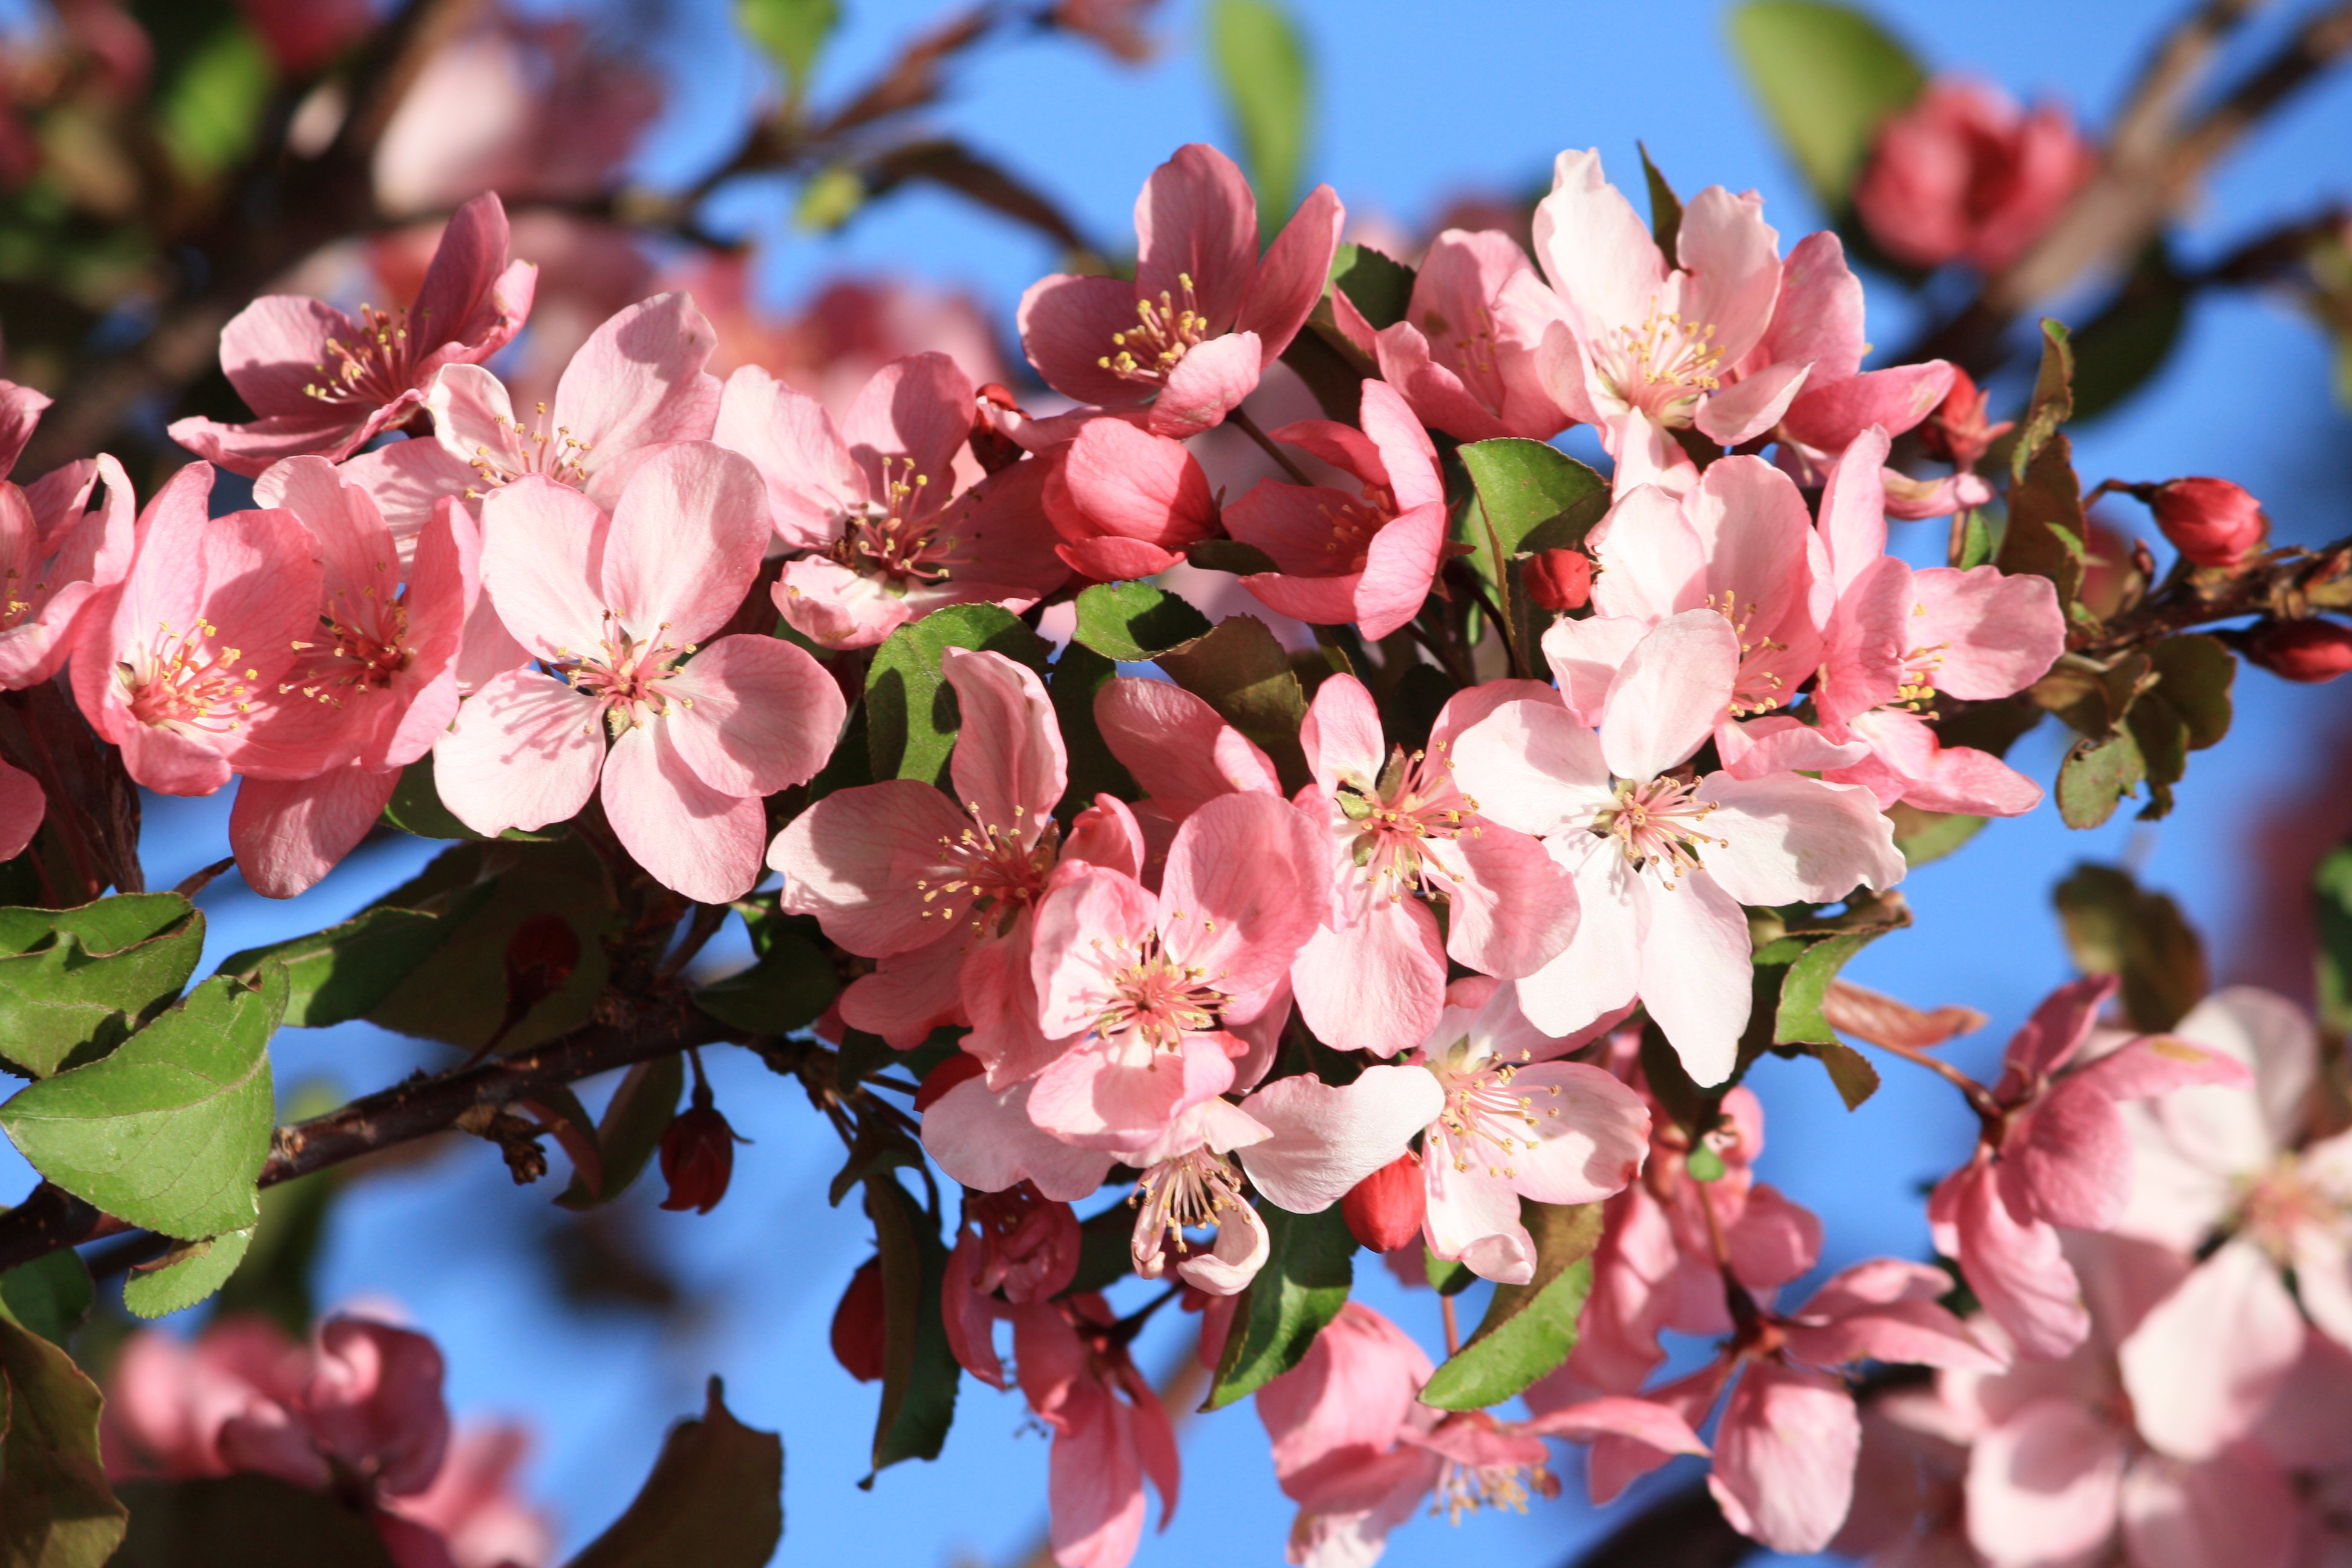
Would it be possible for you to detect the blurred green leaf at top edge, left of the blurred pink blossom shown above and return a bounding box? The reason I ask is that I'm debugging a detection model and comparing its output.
[1731,0,1926,212]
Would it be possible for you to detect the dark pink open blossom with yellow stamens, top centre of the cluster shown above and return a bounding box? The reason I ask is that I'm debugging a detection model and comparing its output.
[1021,141,1345,437]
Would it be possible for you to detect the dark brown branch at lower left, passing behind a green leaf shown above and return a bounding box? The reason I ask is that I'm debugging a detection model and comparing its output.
[0,1001,741,1274]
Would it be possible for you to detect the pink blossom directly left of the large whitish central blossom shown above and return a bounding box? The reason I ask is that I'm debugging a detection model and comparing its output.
[1292,675,1576,1056]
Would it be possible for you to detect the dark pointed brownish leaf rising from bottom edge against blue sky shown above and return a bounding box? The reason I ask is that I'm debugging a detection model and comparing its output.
[569,1377,783,1568]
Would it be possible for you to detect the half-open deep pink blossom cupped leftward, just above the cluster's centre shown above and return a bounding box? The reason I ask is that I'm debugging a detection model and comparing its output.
[1226,381,1446,639]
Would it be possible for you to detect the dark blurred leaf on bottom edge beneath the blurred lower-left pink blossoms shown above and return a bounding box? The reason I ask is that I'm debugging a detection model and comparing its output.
[108,1474,393,1568]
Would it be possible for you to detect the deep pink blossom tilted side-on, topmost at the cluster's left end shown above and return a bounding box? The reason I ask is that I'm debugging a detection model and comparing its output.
[172,195,538,475]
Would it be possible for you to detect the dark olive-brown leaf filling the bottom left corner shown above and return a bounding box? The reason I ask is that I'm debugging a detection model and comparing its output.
[0,1319,125,1568]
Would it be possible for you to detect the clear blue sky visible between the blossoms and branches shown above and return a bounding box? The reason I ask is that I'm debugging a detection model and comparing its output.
[18,0,2352,1568]
